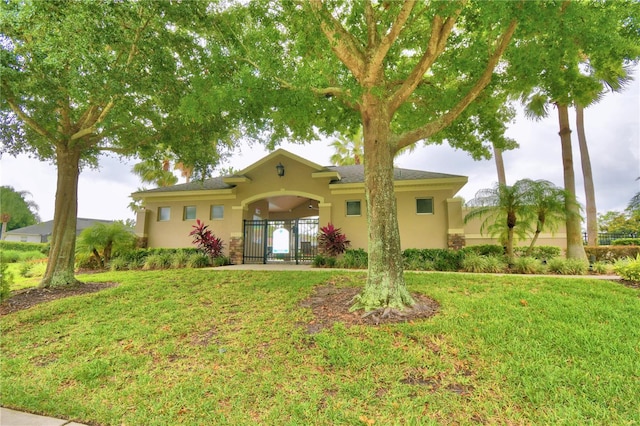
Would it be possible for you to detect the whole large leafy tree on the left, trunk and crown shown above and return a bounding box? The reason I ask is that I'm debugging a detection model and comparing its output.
[0,0,233,287]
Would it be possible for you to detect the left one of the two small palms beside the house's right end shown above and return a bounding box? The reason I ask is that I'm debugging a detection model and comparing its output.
[464,181,533,259]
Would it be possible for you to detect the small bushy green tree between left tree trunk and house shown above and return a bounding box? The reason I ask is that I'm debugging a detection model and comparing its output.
[76,222,136,268]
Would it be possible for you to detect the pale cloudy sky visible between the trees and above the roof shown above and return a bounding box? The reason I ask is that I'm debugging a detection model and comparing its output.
[0,72,640,226]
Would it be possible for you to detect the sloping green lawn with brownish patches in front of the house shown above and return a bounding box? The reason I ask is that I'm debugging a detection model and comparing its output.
[0,270,640,425]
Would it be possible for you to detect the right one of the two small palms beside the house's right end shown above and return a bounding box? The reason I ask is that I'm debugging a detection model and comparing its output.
[518,179,568,255]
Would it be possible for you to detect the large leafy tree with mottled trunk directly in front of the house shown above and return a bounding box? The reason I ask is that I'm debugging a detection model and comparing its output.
[190,0,636,310]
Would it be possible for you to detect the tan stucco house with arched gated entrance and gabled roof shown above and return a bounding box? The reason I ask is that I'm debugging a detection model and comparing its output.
[132,149,467,263]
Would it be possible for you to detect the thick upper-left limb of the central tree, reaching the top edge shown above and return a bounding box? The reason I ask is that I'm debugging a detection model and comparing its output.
[309,0,365,82]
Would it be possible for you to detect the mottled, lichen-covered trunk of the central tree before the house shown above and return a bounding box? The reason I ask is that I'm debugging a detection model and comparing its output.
[352,102,414,311]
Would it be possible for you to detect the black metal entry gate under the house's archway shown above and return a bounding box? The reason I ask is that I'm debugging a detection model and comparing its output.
[242,219,319,265]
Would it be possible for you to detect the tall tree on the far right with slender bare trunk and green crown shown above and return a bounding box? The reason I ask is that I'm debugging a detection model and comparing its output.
[518,1,640,262]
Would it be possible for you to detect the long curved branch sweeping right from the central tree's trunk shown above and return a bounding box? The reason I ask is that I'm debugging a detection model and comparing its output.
[396,20,518,149]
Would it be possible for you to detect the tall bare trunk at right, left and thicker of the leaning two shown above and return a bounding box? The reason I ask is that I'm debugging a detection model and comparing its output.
[557,104,587,262]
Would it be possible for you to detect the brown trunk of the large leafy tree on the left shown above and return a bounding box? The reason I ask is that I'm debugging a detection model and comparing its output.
[40,146,80,287]
